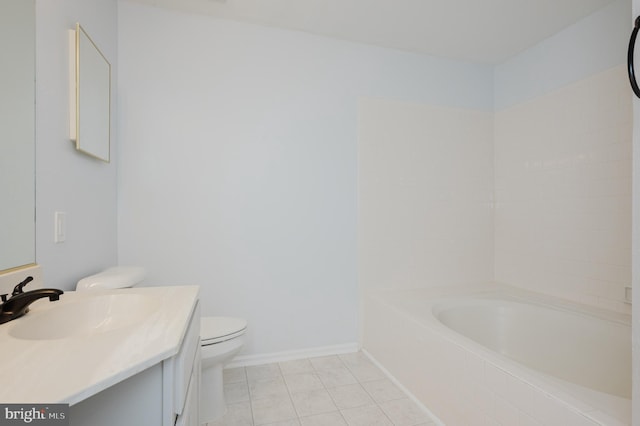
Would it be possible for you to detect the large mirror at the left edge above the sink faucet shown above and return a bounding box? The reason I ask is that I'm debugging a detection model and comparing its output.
[0,0,35,271]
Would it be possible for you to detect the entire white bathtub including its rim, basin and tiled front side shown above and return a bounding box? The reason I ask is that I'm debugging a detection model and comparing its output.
[362,284,632,426]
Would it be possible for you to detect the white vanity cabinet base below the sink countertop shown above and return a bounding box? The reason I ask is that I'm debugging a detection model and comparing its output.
[69,303,201,426]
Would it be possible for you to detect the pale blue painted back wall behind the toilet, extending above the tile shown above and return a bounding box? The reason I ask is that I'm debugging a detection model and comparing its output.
[119,2,492,354]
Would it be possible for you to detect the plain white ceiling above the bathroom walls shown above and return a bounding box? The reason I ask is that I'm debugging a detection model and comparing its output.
[133,0,615,64]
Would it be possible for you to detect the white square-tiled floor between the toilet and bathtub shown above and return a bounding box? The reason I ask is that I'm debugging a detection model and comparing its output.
[208,353,436,426]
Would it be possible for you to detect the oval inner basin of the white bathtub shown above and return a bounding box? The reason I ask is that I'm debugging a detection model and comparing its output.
[433,298,631,399]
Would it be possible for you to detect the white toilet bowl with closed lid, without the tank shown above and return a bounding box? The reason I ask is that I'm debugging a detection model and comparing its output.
[200,317,247,423]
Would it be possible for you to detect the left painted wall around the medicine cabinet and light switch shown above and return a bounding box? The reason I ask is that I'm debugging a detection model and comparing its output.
[36,0,117,289]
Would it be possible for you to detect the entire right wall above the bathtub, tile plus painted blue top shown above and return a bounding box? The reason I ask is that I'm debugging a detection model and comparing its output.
[495,1,632,313]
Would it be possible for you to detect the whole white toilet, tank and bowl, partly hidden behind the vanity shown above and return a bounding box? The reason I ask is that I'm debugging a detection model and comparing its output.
[76,266,247,423]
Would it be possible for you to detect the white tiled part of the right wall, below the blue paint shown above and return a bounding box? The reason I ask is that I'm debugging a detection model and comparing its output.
[495,66,632,313]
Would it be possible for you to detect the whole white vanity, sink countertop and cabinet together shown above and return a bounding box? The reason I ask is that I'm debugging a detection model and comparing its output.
[0,286,200,426]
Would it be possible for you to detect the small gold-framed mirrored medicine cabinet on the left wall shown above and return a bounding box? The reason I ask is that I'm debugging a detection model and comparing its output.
[70,24,111,163]
